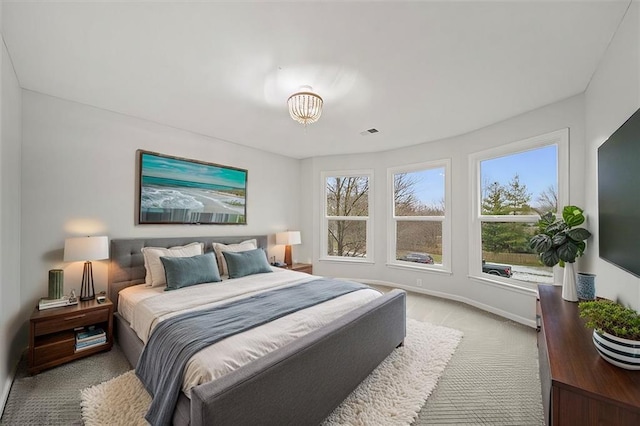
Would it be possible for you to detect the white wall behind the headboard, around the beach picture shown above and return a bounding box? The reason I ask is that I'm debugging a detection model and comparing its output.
[21,91,299,352]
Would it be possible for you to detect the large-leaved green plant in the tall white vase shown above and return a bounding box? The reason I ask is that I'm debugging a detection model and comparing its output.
[529,206,591,266]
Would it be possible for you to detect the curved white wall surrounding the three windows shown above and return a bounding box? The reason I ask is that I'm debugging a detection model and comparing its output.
[301,95,585,325]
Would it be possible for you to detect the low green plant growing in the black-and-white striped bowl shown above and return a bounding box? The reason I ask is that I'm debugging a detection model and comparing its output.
[578,299,640,340]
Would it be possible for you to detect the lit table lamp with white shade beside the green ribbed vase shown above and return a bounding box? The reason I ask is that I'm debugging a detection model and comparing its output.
[64,237,109,301]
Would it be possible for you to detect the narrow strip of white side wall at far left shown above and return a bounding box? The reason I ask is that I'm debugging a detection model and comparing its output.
[0,9,24,412]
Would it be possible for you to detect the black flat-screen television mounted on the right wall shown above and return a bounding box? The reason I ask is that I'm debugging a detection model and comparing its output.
[598,110,640,276]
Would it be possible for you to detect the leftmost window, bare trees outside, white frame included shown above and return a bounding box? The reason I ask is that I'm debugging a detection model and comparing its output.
[321,171,373,261]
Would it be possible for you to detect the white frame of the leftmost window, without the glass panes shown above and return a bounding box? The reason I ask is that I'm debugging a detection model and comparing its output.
[318,169,374,263]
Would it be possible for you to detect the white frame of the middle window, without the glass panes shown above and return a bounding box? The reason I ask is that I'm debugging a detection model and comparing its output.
[387,158,452,274]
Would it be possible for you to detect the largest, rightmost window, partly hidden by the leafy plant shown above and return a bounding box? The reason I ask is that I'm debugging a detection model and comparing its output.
[469,129,569,288]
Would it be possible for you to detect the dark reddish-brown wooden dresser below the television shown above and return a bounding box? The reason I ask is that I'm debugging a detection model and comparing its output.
[537,285,640,426]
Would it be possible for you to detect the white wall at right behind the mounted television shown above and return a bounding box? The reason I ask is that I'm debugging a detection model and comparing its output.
[585,1,640,310]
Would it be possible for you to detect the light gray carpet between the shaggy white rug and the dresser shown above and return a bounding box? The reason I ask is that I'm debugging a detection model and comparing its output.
[414,301,544,426]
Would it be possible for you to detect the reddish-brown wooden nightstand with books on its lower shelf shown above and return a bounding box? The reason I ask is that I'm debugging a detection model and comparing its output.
[29,299,113,374]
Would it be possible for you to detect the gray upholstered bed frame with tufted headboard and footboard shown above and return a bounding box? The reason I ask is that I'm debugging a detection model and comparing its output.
[108,236,406,426]
